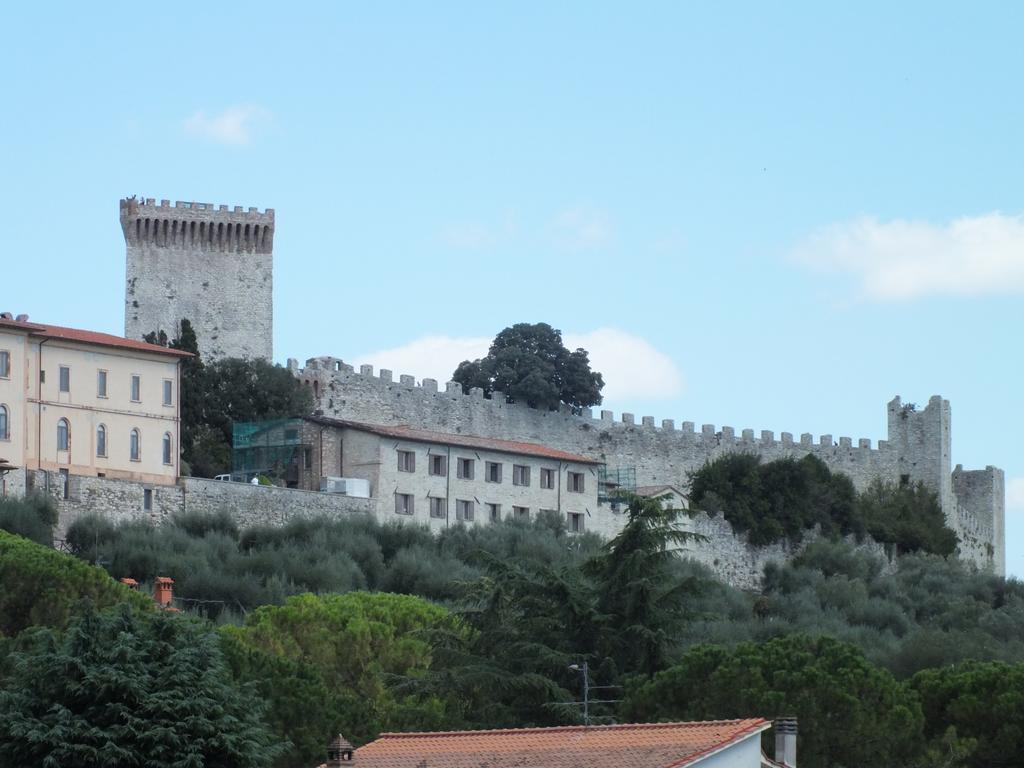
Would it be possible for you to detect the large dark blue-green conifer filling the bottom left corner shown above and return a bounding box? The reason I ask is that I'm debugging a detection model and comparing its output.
[0,605,275,768]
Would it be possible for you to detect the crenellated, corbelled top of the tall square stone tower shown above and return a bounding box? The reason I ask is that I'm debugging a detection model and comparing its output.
[121,198,274,253]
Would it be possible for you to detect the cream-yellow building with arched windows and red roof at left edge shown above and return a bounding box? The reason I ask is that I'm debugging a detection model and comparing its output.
[0,314,189,483]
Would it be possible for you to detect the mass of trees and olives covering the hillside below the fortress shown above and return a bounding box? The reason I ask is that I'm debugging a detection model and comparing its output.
[0,475,1024,768]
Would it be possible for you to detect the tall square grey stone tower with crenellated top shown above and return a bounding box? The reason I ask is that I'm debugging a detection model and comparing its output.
[121,198,273,360]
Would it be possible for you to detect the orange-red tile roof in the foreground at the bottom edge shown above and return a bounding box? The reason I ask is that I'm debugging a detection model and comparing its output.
[354,718,771,768]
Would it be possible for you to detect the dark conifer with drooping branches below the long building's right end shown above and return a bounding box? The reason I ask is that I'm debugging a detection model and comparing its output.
[584,496,702,675]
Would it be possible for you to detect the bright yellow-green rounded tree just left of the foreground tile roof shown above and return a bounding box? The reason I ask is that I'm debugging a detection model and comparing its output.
[221,592,467,766]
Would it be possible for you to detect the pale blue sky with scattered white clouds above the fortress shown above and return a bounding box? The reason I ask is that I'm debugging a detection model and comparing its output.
[0,2,1024,575]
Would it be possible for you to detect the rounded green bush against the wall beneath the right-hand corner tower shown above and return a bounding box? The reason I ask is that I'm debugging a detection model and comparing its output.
[857,479,957,557]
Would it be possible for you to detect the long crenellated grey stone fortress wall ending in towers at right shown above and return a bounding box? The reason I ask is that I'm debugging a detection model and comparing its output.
[289,357,1006,583]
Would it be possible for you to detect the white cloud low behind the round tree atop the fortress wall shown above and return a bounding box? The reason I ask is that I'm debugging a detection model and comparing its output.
[355,328,683,401]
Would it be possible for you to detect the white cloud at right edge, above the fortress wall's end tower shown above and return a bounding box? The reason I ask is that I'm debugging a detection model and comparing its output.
[793,217,1024,301]
